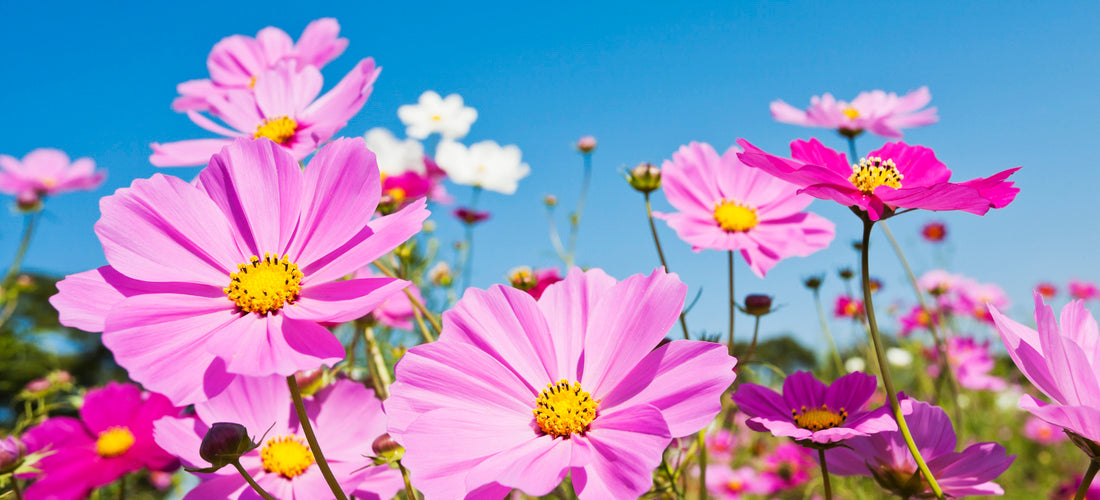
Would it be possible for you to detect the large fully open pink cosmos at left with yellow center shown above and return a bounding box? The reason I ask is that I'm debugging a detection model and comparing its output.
[51,138,428,404]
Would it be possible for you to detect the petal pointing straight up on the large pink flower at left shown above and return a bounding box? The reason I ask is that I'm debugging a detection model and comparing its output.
[198,138,303,256]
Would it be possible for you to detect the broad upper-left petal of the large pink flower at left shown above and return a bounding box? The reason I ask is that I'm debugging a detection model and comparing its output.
[96,174,241,288]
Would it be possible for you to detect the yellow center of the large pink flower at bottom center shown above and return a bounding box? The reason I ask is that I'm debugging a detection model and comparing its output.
[531,379,600,437]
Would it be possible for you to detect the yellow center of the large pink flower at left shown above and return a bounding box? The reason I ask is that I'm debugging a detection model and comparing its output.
[222,254,303,314]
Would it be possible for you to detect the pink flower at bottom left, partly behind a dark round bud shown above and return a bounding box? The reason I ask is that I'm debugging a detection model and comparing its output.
[154,377,405,500]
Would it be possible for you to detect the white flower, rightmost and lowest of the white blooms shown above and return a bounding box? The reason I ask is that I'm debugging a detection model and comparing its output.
[436,141,531,195]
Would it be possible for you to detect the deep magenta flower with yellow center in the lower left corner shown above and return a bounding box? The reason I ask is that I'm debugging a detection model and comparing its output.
[23,382,179,500]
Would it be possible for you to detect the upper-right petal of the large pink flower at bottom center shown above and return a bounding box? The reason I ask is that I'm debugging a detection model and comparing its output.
[581,268,688,398]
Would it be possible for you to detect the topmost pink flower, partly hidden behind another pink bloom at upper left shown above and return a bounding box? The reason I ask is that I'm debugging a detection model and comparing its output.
[172,18,348,112]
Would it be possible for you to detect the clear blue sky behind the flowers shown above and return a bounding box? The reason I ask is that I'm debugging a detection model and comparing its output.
[0,1,1100,351]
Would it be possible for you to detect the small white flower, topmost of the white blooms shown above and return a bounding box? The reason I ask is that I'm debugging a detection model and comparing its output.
[397,90,477,140]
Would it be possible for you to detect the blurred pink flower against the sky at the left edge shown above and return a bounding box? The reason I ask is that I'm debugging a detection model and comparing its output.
[0,147,107,207]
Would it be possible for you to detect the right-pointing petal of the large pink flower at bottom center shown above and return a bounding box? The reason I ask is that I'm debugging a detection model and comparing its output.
[601,341,737,437]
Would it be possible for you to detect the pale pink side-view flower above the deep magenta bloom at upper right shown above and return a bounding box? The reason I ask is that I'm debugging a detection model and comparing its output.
[771,87,939,138]
